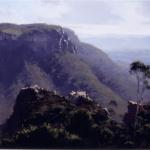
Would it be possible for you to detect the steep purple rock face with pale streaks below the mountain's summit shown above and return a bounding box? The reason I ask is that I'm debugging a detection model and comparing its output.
[18,27,76,54]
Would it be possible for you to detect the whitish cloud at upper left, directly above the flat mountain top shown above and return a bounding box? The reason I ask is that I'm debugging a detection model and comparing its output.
[0,0,68,24]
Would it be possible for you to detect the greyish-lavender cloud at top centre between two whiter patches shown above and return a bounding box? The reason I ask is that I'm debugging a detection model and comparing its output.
[57,0,120,24]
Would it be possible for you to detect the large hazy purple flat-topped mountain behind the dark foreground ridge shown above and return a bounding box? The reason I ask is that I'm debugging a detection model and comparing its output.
[0,24,138,122]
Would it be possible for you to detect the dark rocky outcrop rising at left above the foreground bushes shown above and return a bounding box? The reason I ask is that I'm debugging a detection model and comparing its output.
[3,85,109,134]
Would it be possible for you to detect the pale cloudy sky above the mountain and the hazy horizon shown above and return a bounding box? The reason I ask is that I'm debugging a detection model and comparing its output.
[0,0,150,48]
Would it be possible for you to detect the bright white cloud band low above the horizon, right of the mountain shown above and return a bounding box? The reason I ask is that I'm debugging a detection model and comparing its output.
[68,24,150,39]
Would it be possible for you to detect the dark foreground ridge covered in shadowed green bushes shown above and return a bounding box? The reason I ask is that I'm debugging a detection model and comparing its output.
[1,87,150,148]
